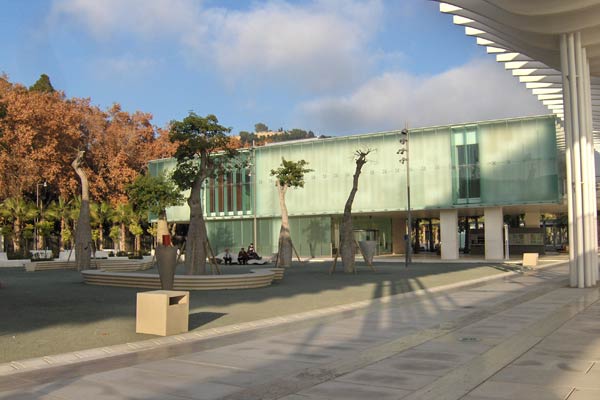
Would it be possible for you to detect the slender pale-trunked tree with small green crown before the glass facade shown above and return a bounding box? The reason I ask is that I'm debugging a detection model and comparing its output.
[271,157,312,267]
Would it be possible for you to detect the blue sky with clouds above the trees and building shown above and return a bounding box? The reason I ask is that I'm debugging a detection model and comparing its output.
[0,0,548,135]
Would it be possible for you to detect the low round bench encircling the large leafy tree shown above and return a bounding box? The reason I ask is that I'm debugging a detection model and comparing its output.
[81,268,283,290]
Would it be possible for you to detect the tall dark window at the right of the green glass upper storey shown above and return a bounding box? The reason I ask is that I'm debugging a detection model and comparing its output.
[452,126,481,204]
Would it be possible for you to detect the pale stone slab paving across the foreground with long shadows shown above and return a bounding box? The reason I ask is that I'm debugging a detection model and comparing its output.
[0,265,600,400]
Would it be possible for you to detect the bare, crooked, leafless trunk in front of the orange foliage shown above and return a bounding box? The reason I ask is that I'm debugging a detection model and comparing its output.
[71,151,92,271]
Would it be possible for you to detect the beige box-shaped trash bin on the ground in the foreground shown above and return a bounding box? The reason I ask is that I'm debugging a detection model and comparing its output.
[135,290,190,336]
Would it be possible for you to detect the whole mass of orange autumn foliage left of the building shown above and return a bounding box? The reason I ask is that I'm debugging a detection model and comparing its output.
[0,76,175,256]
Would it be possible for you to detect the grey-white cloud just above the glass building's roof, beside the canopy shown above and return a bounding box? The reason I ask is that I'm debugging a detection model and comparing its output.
[296,59,549,134]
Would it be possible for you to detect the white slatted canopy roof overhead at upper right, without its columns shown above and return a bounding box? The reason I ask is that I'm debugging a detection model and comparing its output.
[440,0,600,136]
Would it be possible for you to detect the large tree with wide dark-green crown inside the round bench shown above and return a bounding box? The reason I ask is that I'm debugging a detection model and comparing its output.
[170,112,237,274]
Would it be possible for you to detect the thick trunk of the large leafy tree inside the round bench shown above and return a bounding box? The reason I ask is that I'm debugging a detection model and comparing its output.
[185,175,207,275]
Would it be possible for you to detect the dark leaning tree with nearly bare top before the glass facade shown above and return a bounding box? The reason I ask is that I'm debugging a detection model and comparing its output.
[340,149,372,273]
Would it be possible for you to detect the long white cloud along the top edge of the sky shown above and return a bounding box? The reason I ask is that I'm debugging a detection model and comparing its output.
[51,0,383,92]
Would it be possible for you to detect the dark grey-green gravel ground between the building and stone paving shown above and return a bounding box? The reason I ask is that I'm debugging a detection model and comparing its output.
[0,262,506,362]
